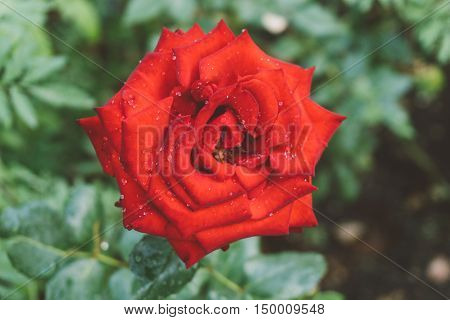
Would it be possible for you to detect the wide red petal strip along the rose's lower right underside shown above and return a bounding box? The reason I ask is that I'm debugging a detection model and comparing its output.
[195,205,291,252]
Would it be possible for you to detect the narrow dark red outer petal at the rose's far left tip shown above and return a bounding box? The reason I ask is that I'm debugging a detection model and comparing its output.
[78,116,114,176]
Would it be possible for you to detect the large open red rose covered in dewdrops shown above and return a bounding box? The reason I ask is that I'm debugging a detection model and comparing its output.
[79,21,344,267]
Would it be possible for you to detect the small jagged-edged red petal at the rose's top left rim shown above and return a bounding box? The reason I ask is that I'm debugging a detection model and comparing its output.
[155,23,205,52]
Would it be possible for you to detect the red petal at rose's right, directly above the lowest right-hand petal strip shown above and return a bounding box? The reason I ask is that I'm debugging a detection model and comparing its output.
[250,177,317,219]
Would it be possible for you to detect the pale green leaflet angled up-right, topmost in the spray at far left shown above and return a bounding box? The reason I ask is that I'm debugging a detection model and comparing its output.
[22,56,67,83]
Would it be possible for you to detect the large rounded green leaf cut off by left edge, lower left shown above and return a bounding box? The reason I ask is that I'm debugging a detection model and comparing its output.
[0,201,71,248]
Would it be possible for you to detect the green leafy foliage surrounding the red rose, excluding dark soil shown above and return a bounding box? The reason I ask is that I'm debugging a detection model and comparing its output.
[0,0,450,299]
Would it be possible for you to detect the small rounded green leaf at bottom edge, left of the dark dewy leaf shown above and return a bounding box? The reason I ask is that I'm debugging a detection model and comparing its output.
[108,269,143,300]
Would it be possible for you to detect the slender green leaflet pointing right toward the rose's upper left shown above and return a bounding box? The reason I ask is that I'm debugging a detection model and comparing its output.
[28,83,95,109]
